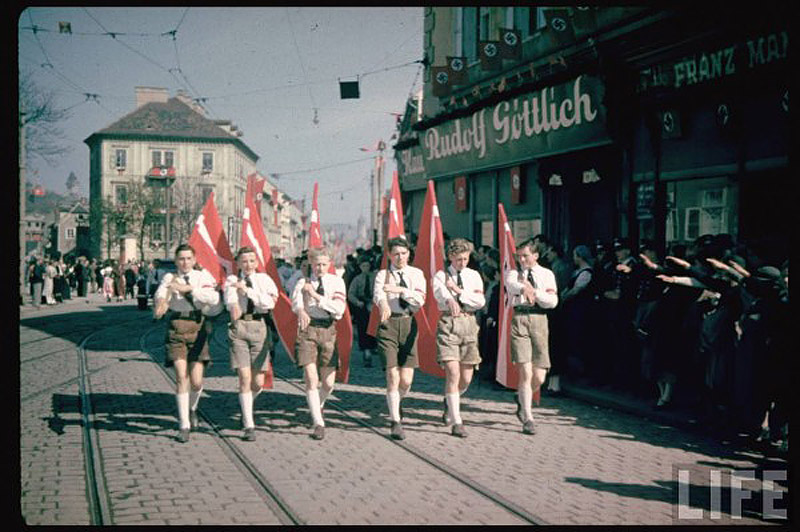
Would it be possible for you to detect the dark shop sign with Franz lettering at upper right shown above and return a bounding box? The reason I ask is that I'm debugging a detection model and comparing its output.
[638,31,789,92]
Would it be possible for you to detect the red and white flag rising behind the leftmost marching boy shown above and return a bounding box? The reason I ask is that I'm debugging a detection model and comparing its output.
[189,192,236,286]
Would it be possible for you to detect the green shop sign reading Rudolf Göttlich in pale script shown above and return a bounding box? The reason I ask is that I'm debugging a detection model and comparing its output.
[418,76,609,178]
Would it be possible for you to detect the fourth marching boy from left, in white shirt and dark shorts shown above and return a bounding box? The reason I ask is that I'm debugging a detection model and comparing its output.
[372,237,427,440]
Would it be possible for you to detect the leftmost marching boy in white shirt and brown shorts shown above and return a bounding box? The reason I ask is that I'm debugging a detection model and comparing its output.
[154,244,222,443]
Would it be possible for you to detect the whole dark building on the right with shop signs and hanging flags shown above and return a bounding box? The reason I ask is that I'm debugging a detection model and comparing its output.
[393,6,788,260]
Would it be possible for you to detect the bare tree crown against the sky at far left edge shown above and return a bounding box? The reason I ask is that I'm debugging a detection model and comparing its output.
[19,73,72,167]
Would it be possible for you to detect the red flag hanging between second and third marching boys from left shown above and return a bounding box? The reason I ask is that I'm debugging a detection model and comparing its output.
[240,197,297,389]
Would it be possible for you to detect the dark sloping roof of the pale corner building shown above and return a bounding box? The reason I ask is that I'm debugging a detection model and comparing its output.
[84,97,258,160]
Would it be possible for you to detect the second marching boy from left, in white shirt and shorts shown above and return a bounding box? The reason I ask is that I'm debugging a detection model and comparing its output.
[225,247,278,441]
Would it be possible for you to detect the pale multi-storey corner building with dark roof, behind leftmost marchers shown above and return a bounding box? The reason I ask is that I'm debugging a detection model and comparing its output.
[85,87,258,260]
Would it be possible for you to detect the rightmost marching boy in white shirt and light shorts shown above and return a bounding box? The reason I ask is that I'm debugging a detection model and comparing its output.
[504,238,558,434]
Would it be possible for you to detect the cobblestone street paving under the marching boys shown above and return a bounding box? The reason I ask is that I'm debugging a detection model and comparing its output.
[20,301,788,525]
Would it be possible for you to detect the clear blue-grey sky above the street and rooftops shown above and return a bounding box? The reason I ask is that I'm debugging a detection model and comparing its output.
[17,7,423,224]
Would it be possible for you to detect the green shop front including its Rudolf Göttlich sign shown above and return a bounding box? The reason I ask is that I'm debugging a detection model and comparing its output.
[396,75,624,254]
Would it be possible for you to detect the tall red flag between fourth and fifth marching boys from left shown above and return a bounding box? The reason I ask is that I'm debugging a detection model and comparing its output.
[414,180,445,377]
